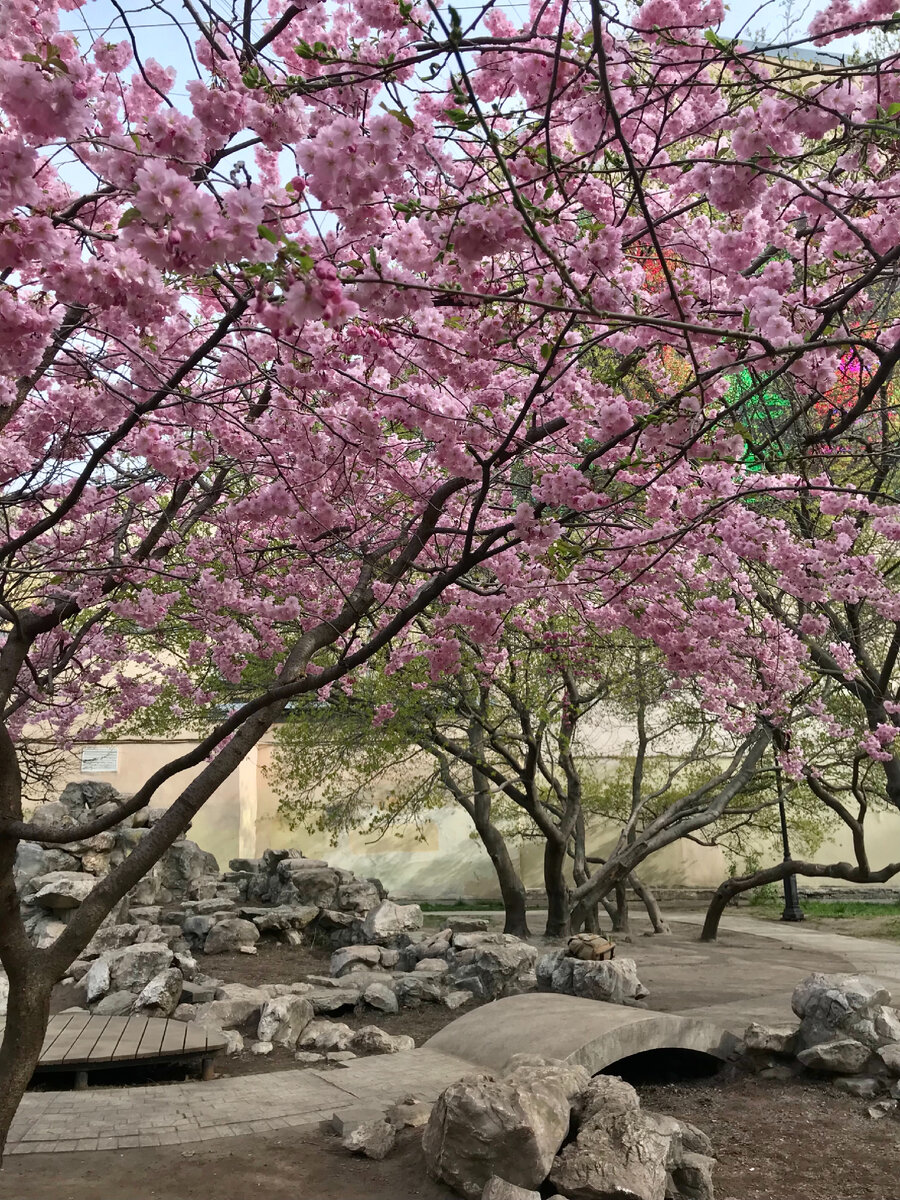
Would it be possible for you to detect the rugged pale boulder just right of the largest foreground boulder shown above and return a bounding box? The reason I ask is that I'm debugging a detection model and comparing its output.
[550,1110,668,1200]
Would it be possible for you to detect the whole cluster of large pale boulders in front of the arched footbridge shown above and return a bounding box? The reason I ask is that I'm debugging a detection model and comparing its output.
[422,1055,715,1200]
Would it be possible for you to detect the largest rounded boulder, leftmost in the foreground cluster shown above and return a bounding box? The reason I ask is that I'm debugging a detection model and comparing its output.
[422,1075,570,1198]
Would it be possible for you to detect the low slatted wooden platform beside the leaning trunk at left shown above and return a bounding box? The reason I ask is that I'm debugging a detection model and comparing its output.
[13,1013,226,1091]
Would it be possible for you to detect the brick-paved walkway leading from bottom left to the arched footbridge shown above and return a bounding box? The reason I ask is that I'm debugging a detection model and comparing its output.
[6,1049,472,1154]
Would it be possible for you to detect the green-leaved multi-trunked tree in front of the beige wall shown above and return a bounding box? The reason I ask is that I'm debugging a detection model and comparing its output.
[271,612,770,936]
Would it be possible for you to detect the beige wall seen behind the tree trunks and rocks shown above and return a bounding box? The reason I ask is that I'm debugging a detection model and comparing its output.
[35,736,900,899]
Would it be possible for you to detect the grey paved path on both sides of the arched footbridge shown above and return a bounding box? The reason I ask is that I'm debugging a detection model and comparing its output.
[7,912,900,1154]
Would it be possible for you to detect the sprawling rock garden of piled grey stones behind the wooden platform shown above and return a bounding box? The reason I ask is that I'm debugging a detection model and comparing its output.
[10,782,647,1073]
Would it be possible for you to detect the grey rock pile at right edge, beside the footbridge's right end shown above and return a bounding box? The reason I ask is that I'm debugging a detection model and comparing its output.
[744,974,900,1116]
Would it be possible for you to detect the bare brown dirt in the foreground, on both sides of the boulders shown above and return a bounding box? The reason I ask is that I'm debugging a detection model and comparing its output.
[7,1076,900,1200]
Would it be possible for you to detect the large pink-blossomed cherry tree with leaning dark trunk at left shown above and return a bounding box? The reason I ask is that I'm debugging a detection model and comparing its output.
[0,0,900,1161]
